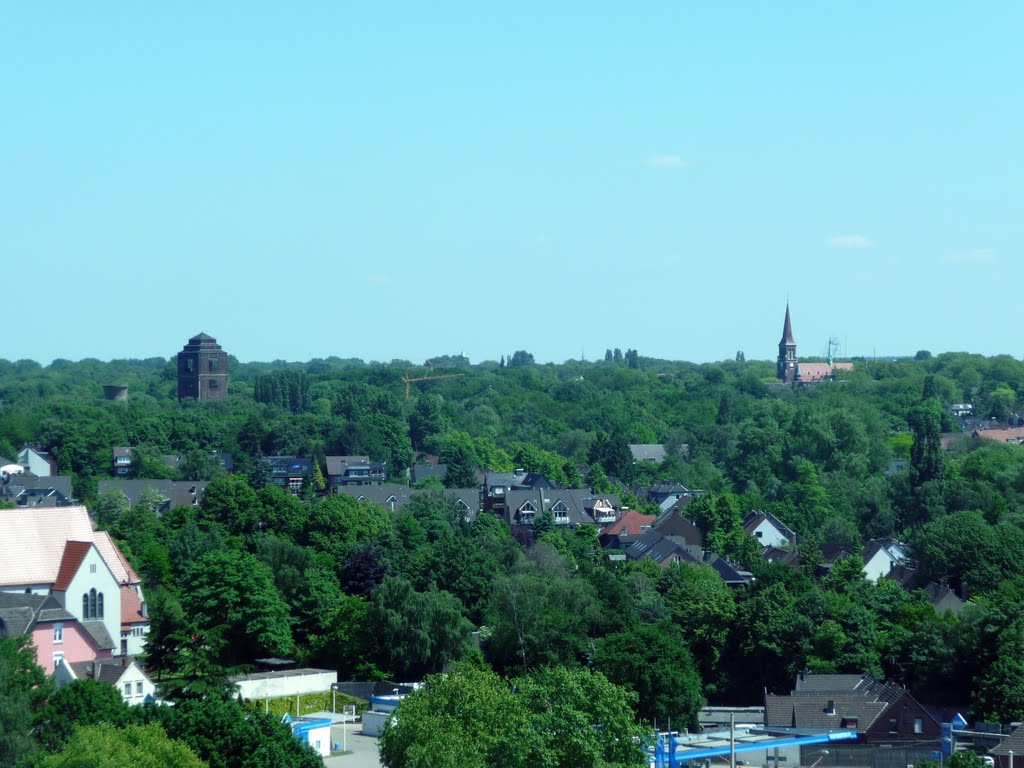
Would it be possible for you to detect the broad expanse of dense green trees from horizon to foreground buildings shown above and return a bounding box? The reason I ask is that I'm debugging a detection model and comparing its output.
[0,350,1024,765]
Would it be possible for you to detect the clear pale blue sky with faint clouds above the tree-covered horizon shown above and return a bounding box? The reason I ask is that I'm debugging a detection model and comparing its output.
[0,5,1024,362]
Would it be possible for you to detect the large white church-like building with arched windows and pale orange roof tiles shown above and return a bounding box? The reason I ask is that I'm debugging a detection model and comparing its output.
[0,506,150,660]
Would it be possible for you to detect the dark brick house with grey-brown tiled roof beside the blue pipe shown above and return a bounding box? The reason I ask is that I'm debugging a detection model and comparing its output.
[765,673,940,749]
